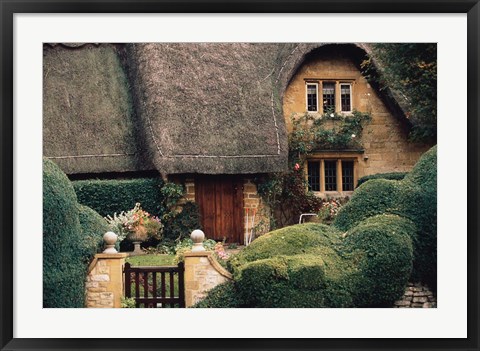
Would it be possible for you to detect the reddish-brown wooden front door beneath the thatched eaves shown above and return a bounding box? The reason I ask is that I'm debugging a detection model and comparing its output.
[195,175,244,244]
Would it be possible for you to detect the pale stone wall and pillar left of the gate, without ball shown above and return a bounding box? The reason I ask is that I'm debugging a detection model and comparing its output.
[85,253,127,308]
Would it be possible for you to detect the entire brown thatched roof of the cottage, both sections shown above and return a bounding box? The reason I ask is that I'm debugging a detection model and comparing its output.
[44,43,408,174]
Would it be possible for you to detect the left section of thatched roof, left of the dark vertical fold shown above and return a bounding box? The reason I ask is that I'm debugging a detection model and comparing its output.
[43,45,152,174]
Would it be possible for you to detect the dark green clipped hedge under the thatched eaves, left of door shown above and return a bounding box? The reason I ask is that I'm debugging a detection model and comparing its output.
[73,178,164,217]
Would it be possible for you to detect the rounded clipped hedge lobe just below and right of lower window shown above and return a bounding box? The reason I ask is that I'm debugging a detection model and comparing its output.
[333,179,400,231]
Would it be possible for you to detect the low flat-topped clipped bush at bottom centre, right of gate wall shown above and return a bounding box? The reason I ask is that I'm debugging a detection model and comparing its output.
[236,253,353,308]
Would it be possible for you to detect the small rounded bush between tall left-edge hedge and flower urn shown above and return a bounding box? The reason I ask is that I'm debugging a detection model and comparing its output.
[78,205,109,261]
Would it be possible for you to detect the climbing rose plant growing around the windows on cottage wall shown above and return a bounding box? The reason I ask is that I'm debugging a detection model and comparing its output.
[256,111,371,229]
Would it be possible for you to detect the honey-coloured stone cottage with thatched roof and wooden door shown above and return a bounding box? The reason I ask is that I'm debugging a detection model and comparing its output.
[43,43,429,243]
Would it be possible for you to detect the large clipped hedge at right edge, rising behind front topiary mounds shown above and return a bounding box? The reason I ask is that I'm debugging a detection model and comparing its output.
[333,146,437,290]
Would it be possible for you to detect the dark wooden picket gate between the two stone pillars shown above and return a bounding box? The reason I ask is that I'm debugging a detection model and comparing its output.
[123,262,185,308]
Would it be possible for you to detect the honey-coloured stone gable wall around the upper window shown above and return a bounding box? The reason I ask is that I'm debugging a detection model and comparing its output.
[283,50,431,183]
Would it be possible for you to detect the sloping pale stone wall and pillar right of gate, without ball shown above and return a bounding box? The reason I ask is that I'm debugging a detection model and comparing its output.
[185,251,232,307]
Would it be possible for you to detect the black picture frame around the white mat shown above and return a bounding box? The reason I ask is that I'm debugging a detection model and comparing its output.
[0,0,480,350]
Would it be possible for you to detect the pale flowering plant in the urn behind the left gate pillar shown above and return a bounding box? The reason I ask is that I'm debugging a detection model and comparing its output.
[105,202,163,241]
